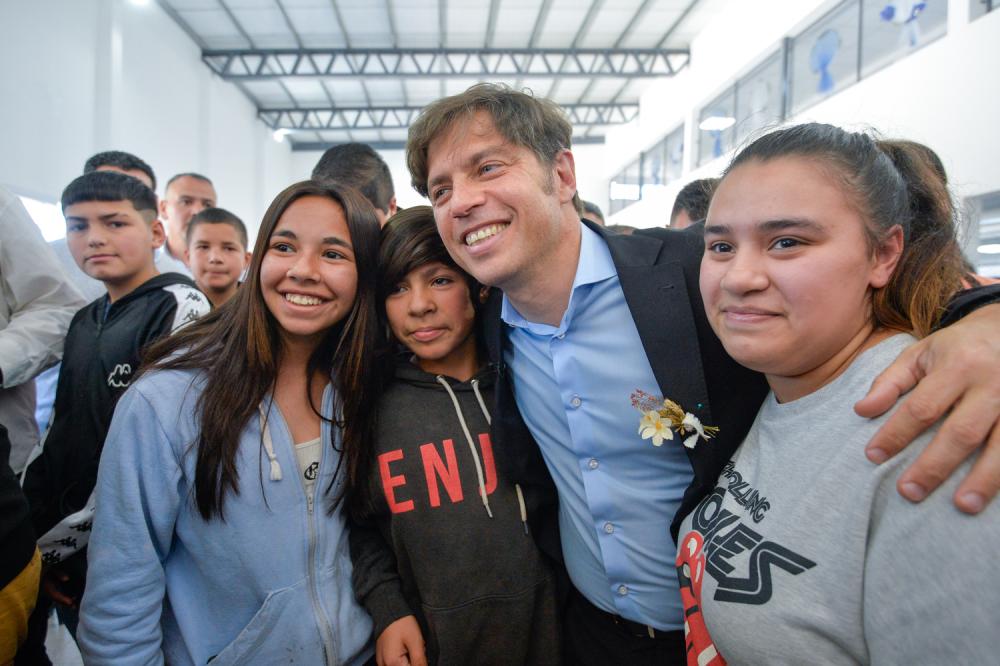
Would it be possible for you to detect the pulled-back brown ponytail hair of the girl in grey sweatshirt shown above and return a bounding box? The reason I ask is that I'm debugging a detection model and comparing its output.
[723,123,963,336]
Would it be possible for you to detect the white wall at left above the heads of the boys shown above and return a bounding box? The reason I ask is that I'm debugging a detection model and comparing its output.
[0,0,292,239]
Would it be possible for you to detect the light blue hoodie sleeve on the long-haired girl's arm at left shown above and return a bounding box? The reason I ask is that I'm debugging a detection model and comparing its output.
[77,387,184,666]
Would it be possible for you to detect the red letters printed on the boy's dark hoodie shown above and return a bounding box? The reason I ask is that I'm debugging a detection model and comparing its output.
[378,433,497,513]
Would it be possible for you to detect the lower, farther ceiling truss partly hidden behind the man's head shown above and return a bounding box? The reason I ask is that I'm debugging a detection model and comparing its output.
[257,104,639,131]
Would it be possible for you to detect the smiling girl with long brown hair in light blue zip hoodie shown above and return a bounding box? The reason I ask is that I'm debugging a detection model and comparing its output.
[80,181,379,664]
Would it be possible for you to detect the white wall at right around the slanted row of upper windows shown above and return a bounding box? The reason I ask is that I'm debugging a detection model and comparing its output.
[604,0,1000,227]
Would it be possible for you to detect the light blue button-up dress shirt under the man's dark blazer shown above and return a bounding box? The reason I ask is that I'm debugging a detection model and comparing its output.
[501,225,693,630]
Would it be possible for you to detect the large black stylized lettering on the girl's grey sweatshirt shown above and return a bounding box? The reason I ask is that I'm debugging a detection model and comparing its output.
[682,487,816,605]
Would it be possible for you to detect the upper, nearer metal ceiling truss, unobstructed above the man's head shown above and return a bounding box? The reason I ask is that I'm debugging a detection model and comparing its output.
[201,48,689,81]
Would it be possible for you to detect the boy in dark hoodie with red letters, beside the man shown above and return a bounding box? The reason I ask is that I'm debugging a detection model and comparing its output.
[349,206,561,666]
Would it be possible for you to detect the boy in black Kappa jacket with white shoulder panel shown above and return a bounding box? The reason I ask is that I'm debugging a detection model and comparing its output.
[24,171,209,652]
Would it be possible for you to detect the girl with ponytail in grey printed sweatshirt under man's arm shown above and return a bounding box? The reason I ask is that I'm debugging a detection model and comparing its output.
[677,124,1000,666]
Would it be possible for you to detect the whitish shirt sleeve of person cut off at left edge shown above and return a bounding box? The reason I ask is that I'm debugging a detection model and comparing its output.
[0,190,84,387]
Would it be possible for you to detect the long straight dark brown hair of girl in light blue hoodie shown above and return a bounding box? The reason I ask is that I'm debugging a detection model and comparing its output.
[142,181,379,520]
